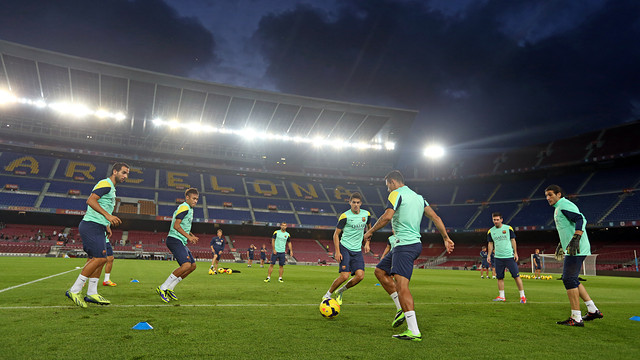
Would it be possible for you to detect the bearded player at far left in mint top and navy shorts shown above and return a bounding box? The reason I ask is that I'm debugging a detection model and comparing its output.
[66,162,129,307]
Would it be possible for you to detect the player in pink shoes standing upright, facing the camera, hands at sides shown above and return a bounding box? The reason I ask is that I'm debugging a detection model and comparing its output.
[487,212,527,304]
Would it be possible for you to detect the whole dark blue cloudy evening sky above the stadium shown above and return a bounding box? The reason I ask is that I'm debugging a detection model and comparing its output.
[0,0,640,157]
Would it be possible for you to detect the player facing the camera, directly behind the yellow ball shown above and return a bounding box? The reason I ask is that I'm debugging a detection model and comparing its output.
[323,192,371,305]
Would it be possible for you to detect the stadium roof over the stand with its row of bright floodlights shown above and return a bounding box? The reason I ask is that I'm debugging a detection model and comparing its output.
[0,40,417,150]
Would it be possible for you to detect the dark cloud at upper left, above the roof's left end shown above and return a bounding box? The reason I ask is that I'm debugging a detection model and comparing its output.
[0,0,216,76]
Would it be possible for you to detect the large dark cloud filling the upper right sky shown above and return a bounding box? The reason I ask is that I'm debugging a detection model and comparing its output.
[254,0,640,145]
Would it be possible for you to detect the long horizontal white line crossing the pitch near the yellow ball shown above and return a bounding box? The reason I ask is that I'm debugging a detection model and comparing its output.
[0,301,640,310]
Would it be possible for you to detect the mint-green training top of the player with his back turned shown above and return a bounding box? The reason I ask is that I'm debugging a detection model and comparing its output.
[387,185,429,245]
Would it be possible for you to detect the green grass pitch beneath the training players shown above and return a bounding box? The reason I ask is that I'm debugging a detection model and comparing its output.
[0,257,640,359]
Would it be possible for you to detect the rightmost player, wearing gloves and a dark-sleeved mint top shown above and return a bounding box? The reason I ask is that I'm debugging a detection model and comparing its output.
[544,185,604,326]
